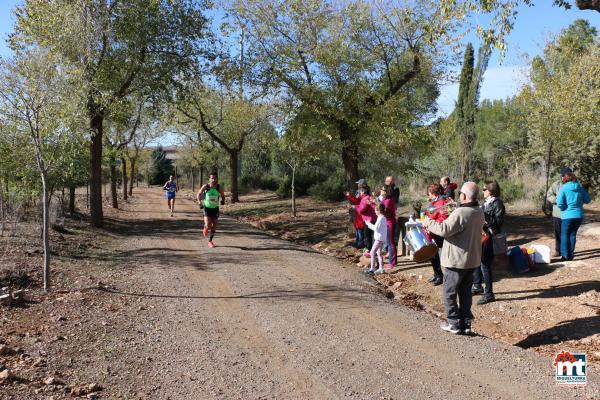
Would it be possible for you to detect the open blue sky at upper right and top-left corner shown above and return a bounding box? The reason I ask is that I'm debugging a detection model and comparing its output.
[0,0,600,120]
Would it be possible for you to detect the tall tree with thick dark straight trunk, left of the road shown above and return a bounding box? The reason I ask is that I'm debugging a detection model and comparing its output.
[12,0,207,227]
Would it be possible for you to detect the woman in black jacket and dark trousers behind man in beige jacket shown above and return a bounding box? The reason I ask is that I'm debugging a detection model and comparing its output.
[472,181,505,305]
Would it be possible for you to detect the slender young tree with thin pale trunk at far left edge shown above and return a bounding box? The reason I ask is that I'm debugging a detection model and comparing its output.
[0,49,79,290]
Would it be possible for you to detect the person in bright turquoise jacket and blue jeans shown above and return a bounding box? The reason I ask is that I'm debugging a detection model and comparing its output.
[556,172,592,261]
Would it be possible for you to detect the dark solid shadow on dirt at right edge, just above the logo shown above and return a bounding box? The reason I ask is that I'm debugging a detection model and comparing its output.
[515,316,600,349]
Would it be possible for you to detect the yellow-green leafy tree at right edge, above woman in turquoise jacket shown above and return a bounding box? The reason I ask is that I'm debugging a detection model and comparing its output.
[522,21,600,205]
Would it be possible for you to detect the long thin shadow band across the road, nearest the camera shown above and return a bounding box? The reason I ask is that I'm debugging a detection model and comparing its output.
[92,285,369,302]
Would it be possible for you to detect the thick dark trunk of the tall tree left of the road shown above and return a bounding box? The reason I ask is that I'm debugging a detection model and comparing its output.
[88,111,104,228]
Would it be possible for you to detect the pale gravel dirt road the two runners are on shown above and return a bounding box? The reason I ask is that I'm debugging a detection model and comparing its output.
[15,190,600,400]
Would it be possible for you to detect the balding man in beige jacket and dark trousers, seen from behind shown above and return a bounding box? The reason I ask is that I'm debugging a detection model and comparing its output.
[424,182,485,335]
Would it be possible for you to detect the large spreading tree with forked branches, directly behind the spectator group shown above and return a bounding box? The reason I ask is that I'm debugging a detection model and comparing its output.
[233,0,464,187]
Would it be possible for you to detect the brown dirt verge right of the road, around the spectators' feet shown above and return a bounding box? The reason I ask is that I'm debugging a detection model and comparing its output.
[228,192,600,361]
